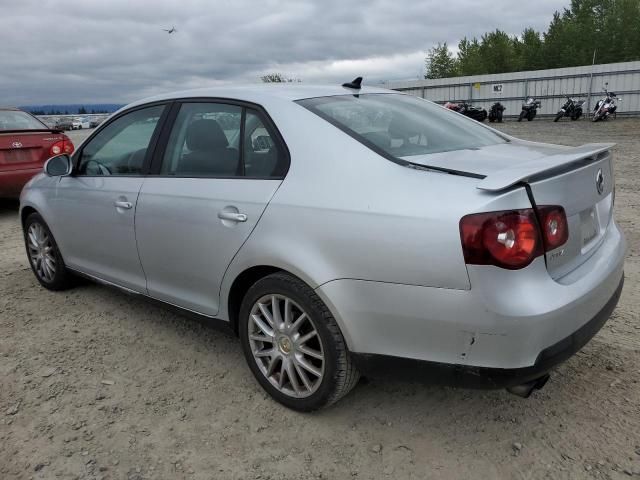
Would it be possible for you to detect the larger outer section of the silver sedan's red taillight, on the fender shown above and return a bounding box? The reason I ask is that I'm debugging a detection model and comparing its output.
[460,209,542,270]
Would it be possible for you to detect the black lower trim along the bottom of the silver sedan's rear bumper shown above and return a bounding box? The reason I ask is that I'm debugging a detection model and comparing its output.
[352,277,624,388]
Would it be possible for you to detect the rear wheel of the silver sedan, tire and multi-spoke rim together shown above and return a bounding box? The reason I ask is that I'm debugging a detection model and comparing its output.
[239,273,360,412]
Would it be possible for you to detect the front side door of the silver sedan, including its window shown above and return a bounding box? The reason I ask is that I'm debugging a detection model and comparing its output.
[54,105,165,293]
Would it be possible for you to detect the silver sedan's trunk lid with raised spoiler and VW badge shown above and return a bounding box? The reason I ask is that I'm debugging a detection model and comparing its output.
[404,141,614,278]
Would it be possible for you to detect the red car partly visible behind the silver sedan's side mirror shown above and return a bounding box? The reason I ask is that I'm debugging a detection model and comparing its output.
[0,107,74,198]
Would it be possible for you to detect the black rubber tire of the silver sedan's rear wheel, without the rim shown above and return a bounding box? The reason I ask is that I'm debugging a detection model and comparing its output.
[238,272,360,412]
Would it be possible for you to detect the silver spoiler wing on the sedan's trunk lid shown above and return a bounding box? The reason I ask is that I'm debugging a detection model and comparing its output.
[477,143,615,192]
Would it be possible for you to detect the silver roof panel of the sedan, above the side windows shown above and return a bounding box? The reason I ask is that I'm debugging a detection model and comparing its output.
[123,82,398,110]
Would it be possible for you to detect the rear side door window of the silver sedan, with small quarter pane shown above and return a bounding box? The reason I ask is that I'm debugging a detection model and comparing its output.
[160,102,286,178]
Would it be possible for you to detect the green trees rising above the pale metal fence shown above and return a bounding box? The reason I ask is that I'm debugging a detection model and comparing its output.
[425,0,640,78]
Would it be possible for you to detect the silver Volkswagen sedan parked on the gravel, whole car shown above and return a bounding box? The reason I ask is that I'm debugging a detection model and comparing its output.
[21,83,626,411]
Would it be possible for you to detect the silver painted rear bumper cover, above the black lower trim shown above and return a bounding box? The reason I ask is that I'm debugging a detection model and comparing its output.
[316,222,626,372]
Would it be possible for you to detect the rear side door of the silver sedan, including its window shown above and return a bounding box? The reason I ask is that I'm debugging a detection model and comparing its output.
[136,101,288,315]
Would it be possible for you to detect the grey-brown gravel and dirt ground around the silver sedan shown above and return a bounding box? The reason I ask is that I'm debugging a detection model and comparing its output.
[0,119,640,479]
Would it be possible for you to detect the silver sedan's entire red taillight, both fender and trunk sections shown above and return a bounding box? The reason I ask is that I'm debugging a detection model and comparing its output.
[460,206,569,270]
